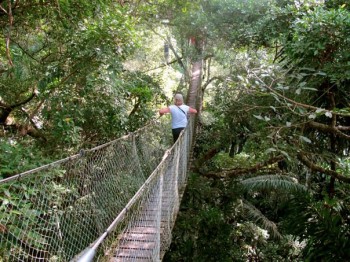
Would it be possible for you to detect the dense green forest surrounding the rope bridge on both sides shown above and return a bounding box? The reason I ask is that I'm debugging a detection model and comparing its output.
[0,0,350,262]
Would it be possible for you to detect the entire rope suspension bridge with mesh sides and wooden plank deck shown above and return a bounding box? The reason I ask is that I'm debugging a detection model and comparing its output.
[0,118,194,262]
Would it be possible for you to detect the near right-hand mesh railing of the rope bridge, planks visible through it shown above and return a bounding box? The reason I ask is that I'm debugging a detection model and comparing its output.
[74,119,194,262]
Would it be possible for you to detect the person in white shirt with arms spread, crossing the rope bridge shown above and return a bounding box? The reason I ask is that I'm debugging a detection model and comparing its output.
[159,94,197,143]
